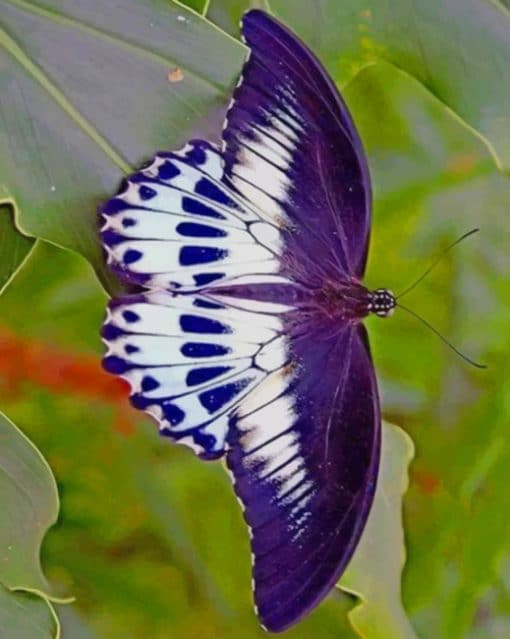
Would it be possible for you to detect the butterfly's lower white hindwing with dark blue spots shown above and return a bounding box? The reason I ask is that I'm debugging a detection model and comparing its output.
[103,291,289,458]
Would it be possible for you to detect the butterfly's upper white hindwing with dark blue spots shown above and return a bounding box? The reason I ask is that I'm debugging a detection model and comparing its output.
[101,141,287,292]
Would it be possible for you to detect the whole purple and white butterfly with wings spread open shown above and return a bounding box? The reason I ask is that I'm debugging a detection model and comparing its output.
[101,10,395,632]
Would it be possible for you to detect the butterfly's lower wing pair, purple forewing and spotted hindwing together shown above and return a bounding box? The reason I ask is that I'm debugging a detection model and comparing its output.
[103,291,380,631]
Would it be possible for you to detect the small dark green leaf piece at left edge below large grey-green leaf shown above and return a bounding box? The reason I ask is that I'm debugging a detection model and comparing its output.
[0,204,34,293]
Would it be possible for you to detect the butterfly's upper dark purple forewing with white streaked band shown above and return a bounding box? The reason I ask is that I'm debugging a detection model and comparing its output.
[223,10,371,277]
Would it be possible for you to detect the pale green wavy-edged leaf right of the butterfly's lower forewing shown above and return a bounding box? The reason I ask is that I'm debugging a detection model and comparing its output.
[338,423,416,639]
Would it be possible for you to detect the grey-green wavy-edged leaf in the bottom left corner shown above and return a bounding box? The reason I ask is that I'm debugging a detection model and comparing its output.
[0,414,58,639]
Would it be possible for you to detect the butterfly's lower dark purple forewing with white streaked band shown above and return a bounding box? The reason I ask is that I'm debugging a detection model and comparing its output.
[227,322,380,632]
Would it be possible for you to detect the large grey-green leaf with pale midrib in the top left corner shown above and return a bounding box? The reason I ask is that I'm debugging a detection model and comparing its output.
[0,0,244,288]
